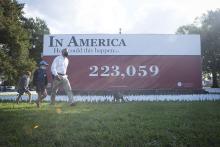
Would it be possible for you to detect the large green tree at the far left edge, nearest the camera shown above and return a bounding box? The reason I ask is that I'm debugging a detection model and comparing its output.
[0,0,36,84]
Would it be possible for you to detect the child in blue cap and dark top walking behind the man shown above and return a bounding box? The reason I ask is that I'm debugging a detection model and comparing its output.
[33,61,48,108]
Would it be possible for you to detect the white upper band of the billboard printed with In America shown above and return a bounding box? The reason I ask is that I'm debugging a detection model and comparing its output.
[43,34,201,56]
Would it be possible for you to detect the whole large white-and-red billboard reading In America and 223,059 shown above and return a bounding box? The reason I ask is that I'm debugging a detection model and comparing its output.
[43,34,201,91]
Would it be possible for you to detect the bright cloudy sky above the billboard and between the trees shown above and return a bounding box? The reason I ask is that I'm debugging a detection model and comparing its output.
[18,0,220,34]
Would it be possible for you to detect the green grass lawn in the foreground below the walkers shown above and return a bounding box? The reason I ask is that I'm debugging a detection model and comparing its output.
[0,101,220,147]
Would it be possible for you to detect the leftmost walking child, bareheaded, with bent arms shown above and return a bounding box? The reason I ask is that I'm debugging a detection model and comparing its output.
[16,71,31,104]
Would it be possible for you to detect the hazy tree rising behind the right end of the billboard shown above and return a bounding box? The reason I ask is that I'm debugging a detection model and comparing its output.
[177,9,220,87]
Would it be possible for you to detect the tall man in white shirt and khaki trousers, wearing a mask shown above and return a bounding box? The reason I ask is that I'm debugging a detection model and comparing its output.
[51,48,76,106]
